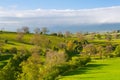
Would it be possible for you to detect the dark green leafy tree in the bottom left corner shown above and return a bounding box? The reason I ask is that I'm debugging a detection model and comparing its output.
[0,53,29,80]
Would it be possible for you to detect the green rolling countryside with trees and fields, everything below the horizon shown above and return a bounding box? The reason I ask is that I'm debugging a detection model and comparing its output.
[0,31,120,80]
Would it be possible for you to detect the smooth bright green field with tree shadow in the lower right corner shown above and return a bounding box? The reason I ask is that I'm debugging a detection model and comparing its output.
[60,58,120,80]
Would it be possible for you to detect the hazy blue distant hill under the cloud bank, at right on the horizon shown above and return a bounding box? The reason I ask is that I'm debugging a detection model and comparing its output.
[49,23,120,32]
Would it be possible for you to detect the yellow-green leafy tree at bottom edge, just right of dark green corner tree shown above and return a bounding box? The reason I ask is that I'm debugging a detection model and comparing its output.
[17,53,42,80]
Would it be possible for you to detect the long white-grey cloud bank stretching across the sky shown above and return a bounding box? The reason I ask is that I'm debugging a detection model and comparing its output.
[0,6,120,26]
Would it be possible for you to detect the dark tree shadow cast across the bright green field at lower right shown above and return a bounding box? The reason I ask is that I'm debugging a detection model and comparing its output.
[63,63,108,76]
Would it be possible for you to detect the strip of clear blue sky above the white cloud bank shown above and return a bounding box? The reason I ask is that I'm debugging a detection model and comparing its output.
[0,0,120,10]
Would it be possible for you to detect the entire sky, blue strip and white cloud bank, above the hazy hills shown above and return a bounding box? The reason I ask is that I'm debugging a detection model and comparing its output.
[0,0,120,30]
